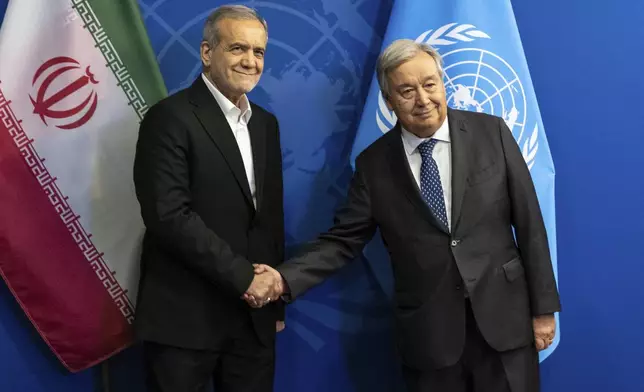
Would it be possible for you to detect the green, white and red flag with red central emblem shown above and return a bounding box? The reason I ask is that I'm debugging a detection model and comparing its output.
[0,0,166,371]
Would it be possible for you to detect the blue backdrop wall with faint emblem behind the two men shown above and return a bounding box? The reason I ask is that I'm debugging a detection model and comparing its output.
[0,0,644,392]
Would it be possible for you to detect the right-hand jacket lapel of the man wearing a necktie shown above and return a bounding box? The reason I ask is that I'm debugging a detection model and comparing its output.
[447,109,469,233]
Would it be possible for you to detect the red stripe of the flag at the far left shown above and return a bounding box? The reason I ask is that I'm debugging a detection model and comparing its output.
[0,84,134,371]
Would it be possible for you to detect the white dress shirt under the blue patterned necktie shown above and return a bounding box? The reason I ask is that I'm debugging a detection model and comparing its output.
[401,117,452,230]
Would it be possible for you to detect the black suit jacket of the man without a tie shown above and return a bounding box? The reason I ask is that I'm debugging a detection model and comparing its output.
[134,76,284,349]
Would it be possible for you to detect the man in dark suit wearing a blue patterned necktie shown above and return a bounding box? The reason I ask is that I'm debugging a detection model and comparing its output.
[246,40,560,392]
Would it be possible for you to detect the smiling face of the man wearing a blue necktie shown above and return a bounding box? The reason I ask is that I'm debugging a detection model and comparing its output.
[386,52,447,138]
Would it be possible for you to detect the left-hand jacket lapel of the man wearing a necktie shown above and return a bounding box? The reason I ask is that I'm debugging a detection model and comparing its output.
[389,124,447,231]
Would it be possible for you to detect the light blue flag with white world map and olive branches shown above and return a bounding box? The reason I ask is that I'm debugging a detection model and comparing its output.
[351,0,560,360]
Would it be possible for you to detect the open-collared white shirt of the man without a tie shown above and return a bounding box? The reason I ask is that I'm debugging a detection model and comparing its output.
[201,74,257,208]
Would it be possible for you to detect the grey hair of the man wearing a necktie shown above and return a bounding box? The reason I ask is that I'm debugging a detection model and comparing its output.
[376,39,443,97]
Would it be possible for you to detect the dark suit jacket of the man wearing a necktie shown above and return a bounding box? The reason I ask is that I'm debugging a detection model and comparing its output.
[278,109,560,369]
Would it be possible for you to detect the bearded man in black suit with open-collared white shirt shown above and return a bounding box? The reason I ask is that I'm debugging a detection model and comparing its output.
[134,6,284,392]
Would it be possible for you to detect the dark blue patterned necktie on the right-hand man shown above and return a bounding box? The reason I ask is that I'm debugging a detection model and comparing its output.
[418,139,449,231]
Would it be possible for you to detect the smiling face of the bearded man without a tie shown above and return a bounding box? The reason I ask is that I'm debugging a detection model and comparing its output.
[201,19,268,105]
